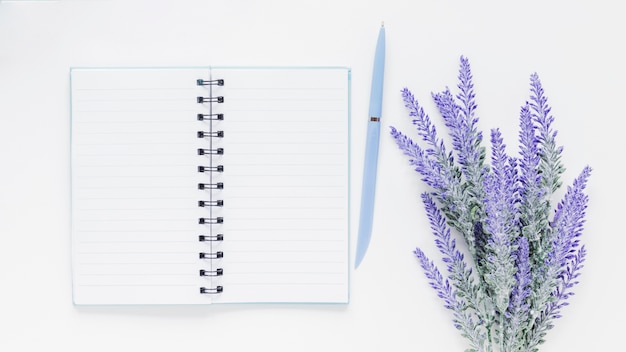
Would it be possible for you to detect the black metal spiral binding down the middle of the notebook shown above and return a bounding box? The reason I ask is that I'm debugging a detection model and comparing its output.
[196,75,224,294]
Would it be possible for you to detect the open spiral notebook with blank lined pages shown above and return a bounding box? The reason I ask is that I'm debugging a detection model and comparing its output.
[70,67,350,305]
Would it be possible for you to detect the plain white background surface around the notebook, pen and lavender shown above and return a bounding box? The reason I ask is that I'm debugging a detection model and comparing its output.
[0,0,626,352]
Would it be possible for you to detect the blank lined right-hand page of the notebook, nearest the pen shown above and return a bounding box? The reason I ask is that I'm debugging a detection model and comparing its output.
[212,68,349,302]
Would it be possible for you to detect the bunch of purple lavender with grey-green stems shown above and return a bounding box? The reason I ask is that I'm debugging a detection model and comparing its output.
[391,57,591,352]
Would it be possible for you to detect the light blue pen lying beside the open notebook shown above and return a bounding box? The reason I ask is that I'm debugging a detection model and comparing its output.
[354,23,385,268]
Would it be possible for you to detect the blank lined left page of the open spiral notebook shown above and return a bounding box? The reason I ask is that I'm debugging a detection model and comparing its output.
[71,69,212,304]
